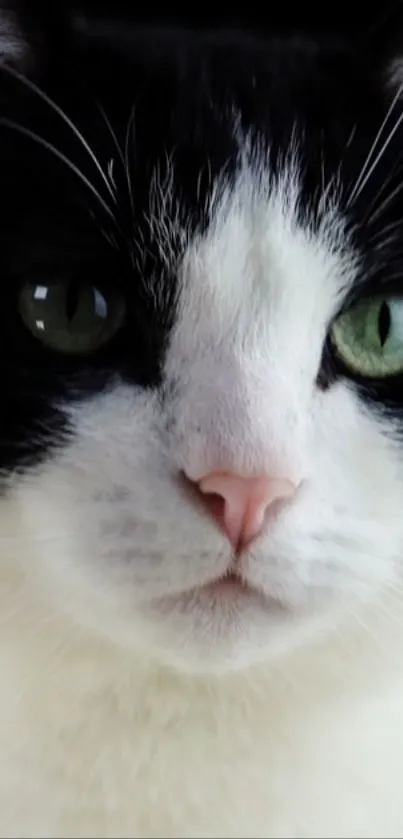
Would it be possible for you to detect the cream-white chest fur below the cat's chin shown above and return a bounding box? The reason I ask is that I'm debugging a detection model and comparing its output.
[0,628,403,837]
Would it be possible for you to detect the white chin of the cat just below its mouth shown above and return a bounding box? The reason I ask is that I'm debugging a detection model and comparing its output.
[93,584,333,675]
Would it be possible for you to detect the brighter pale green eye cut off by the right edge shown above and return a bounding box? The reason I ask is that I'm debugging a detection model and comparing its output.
[331,296,403,379]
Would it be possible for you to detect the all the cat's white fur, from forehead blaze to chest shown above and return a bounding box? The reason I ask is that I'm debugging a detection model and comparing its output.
[0,156,403,837]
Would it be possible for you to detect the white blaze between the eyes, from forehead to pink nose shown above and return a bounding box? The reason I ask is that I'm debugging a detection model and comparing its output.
[166,157,357,479]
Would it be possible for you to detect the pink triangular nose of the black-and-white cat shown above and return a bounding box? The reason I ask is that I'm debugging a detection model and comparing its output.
[199,472,296,551]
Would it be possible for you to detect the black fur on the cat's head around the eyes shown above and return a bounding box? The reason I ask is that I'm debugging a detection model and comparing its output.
[0,0,403,472]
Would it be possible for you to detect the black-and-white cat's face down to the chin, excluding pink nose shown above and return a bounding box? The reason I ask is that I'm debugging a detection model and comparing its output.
[0,0,403,670]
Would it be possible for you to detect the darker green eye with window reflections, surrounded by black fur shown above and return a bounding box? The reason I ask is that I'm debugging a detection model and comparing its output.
[19,278,125,355]
